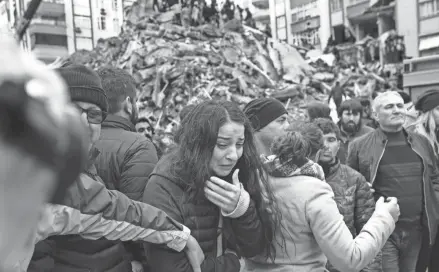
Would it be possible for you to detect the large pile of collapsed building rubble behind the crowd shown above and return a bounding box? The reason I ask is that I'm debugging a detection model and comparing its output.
[63,0,404,142]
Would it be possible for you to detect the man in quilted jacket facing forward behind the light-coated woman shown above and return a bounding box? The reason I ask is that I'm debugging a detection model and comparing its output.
[312,118,382,272]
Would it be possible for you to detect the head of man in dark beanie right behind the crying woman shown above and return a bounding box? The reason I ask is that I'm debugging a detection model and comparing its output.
[244,98,290,158]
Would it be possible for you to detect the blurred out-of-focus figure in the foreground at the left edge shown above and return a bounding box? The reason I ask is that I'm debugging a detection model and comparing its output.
[0,36,88,271]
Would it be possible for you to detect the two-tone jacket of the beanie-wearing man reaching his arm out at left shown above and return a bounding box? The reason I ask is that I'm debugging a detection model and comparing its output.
[28,150,189,272]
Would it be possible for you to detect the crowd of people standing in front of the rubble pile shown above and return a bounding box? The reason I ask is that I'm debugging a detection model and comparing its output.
[0,38,439,272]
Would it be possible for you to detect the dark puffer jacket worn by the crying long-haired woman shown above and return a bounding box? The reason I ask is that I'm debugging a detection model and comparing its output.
[143,153,265,272]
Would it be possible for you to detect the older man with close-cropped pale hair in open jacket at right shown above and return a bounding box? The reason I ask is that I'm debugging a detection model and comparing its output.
[347,91,439,272]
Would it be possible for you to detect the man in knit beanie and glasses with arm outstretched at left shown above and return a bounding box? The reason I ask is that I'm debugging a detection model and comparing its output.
[29,66,202,272]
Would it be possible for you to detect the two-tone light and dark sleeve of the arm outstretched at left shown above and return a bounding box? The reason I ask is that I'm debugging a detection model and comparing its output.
[39,174,190,251]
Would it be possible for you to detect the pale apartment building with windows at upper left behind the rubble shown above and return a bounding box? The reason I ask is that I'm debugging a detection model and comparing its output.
[2,0,124,63]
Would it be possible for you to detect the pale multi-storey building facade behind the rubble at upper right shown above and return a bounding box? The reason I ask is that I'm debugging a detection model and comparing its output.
[267,0,439,57]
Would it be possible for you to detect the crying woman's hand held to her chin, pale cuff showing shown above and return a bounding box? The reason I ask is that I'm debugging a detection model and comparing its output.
[204,169,241,214]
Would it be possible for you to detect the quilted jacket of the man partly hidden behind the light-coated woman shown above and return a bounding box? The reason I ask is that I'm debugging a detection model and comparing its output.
[323,160,382,272]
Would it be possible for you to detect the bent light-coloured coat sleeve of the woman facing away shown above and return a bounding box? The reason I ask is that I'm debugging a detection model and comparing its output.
[306,178,395,271]
